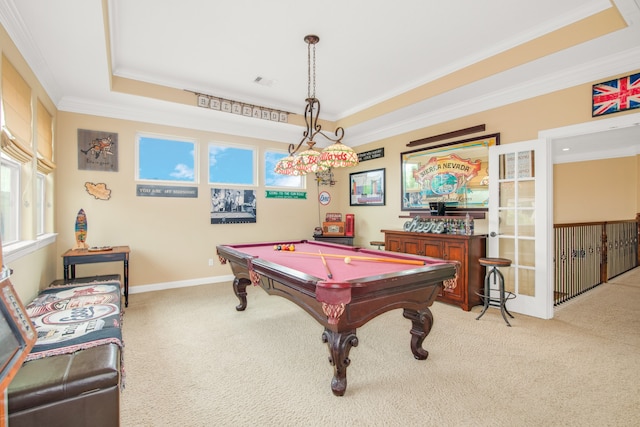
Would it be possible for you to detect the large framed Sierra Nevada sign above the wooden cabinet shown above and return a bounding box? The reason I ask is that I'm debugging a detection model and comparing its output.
[400,133,500,211]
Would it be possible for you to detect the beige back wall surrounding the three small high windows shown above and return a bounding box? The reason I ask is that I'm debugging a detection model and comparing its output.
[56,112,318,286]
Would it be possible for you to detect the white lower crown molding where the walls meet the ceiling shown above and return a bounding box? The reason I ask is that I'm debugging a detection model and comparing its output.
[5,0,640,147]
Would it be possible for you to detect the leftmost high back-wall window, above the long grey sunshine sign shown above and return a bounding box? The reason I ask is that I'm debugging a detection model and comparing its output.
[136,135,198,184]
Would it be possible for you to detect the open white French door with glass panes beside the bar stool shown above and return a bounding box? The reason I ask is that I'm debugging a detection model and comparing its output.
[487,139,553,319]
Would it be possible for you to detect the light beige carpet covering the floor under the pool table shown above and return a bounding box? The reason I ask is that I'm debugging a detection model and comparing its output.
[121,268,640,427]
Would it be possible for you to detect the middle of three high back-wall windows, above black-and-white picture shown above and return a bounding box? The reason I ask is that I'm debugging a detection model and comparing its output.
[209,143,256,186]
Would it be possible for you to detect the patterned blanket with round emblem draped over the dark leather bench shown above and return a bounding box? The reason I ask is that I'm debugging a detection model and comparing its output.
[25,281,122,360]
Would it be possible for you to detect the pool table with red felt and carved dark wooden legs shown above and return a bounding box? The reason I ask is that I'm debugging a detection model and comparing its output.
[216,240,457,396]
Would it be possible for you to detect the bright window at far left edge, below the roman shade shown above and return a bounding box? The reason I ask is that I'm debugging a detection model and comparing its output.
[0,154,20,245]
